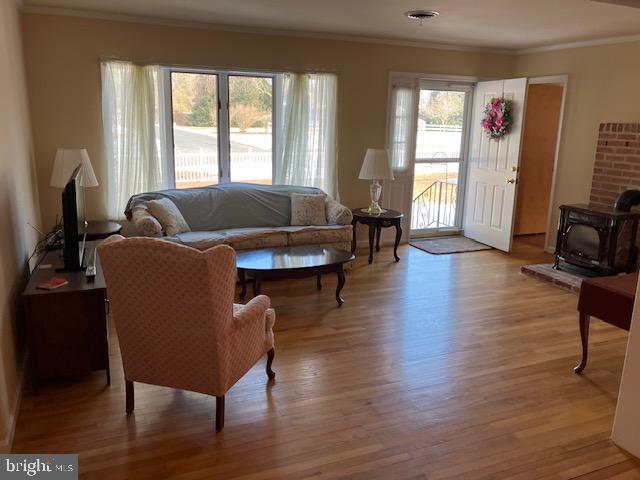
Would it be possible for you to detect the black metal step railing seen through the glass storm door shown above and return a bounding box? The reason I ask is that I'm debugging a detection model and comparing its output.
[411,180,458,230]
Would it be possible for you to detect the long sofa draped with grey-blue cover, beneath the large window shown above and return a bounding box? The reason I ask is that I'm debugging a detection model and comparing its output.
[125,183,353,250]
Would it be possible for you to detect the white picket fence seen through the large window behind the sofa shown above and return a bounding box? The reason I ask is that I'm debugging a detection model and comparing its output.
[174,152,272,183]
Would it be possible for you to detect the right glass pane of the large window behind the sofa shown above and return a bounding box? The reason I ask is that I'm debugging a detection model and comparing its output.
[228,75,273,184]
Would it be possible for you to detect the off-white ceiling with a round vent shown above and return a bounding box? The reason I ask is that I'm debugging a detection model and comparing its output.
[24,0,640,50]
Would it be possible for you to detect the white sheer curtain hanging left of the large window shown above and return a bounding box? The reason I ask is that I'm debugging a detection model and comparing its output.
[101,61,167,220]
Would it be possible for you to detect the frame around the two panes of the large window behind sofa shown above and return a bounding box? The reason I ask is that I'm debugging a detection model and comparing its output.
[160,66,282,188]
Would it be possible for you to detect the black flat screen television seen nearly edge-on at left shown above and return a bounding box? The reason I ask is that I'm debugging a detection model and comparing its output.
[62,165,87,272]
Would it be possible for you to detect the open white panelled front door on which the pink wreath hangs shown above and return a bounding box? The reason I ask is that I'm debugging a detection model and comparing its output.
[463,78,527,252]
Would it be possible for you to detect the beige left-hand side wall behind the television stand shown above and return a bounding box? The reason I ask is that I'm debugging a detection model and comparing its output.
[0,0,40,451]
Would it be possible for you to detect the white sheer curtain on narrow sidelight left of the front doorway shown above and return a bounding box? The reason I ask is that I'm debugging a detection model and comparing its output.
[389,84,418,172]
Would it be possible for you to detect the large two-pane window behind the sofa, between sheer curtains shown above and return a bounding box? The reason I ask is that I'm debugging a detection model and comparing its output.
[168,69,274,188]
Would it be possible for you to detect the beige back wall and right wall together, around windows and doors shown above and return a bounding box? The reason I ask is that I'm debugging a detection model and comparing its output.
[17,14,640,244]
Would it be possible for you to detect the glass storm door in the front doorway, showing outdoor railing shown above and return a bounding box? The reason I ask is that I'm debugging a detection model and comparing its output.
[411,87,470,234]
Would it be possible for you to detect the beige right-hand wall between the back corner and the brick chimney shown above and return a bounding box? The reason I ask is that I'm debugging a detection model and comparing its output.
[513,42,640,249]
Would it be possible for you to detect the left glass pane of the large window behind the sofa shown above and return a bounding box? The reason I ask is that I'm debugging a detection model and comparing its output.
[171,72,220,188]
